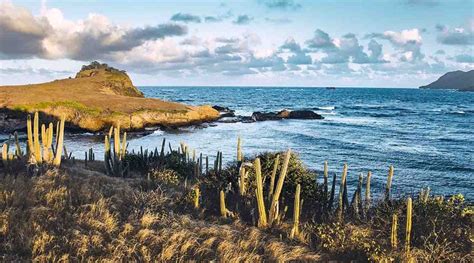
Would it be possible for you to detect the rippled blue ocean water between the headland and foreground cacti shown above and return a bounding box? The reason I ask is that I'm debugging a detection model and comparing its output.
[3,87,474,200]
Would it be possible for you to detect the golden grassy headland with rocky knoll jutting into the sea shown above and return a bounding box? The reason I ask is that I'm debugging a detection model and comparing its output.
[0,62,219,132]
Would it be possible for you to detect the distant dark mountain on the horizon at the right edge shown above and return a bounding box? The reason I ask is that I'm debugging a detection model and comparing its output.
[420,70,474,91]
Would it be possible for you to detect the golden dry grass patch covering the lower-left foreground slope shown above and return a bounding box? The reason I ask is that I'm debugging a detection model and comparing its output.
[0,167,320,262]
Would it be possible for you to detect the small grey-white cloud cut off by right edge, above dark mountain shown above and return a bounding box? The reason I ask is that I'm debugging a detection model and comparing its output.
[436,19,474,45]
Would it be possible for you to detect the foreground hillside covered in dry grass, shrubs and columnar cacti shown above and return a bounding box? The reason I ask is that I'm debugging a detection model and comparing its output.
[0,116,474,262]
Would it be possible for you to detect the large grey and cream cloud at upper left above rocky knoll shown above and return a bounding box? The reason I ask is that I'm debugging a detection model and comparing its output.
[0,2,187,60]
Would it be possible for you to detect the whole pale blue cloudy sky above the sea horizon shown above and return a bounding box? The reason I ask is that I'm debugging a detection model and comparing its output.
[0,0,474,87]
